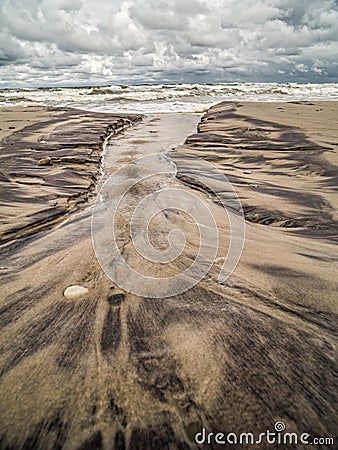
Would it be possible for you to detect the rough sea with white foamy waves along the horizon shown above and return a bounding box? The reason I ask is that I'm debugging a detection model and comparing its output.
[0,83,338,114]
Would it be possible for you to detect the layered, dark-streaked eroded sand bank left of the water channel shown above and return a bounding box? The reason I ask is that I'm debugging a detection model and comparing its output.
[0,107,140,243]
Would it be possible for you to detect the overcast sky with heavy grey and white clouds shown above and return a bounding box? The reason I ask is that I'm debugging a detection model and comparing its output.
[0,0,338,87]
